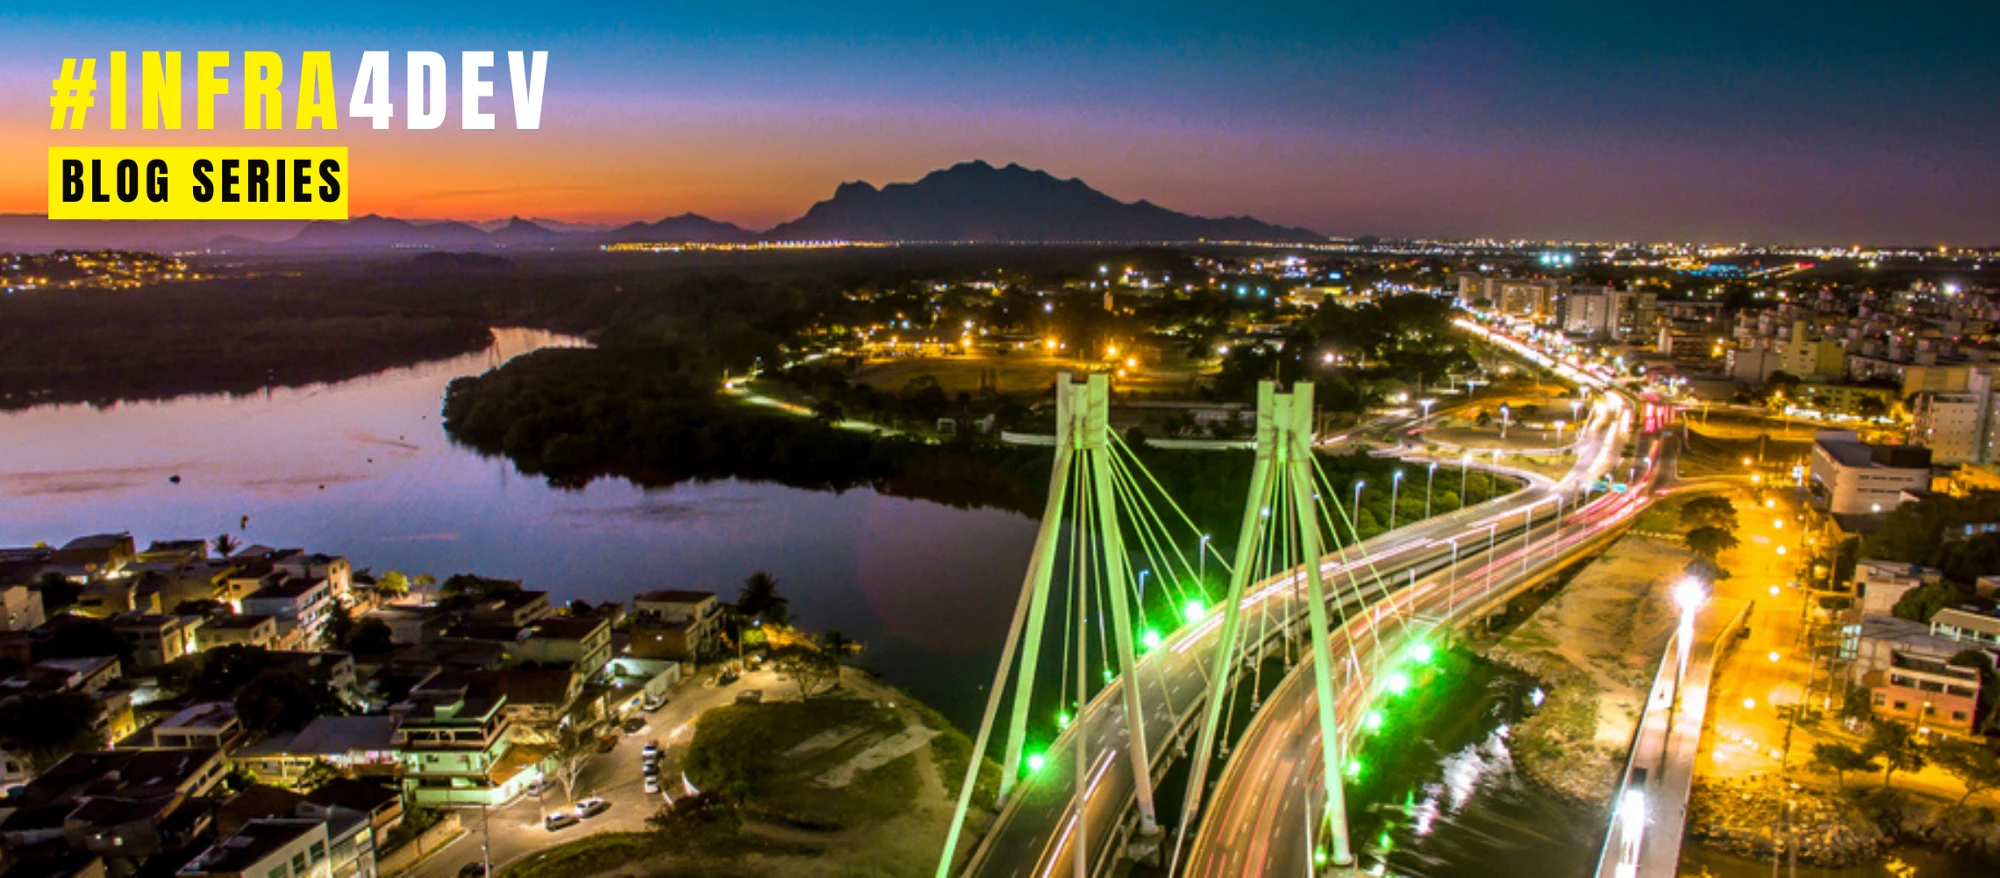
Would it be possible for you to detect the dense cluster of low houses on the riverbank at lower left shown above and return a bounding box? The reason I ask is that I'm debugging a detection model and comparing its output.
[0,534,764,878]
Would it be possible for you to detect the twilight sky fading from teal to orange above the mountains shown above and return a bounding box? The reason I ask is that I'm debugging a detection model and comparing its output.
[0,0,2000,244]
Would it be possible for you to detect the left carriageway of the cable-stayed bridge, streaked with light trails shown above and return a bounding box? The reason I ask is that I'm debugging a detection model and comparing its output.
[966,328,1632,878]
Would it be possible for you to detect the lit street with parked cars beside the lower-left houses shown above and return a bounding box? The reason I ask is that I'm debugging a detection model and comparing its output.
[408,670,798,878]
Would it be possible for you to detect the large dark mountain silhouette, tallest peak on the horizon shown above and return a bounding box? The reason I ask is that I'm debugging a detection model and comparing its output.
[764,162,1326,242]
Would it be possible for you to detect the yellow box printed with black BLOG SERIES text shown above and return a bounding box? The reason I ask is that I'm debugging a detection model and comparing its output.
[48,146,348,220]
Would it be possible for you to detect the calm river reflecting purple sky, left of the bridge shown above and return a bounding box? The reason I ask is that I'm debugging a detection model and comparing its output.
[0,330,1034,728]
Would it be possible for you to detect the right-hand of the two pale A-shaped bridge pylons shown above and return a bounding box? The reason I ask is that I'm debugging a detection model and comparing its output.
[1168,382,1354,874]
